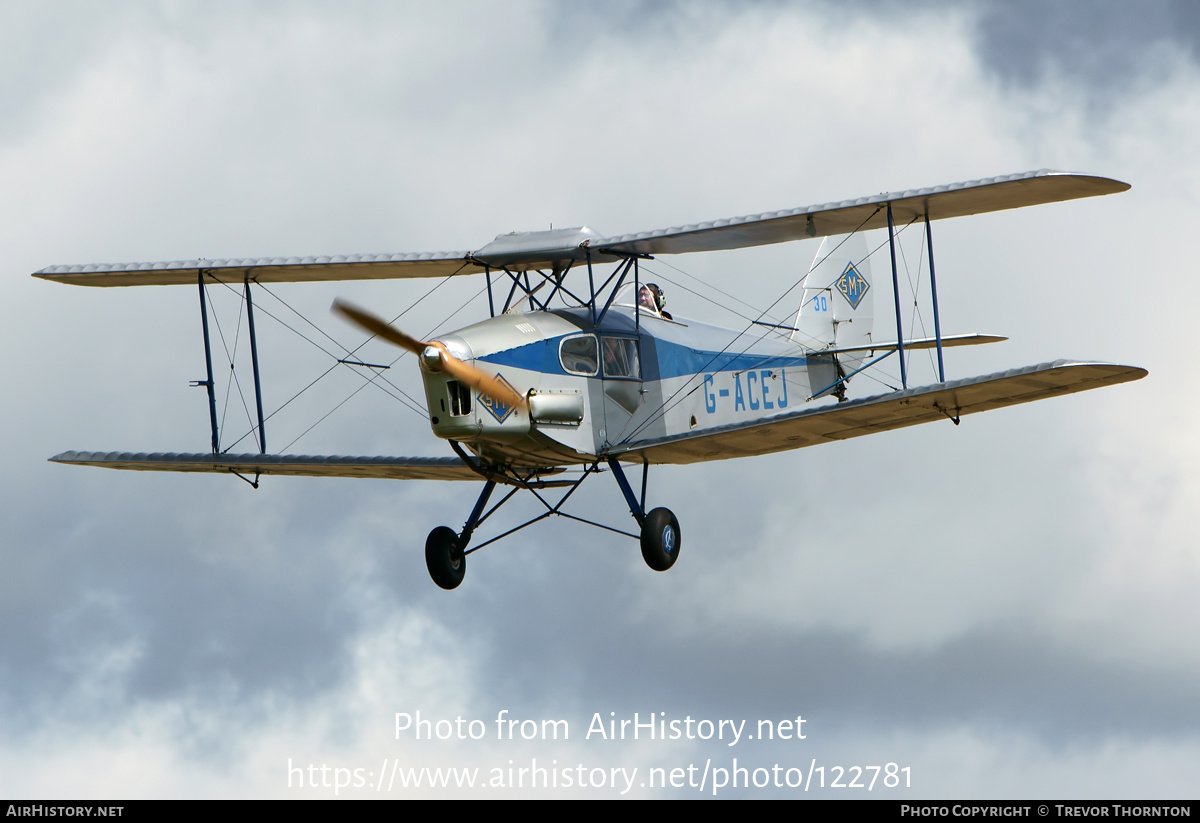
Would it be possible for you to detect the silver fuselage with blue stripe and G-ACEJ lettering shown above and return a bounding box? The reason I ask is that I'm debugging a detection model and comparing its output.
[422,306,811,468]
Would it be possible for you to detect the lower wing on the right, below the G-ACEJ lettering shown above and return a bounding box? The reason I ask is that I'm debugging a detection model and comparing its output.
[629,360,1147,463]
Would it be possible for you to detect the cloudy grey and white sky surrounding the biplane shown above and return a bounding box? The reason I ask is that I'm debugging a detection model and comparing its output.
[0,0,1200,799]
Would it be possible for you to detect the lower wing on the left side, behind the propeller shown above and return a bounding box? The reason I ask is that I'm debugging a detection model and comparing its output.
[50,451,480,480]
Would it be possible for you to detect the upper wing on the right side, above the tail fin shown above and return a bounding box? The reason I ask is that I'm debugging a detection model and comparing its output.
[602,169,1129,261]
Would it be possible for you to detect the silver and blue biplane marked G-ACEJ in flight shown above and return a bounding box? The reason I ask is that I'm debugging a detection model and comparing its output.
[34,169,1146,589]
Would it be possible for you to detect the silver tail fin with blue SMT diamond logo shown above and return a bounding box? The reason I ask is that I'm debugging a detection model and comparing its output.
[792,232,875,397]
